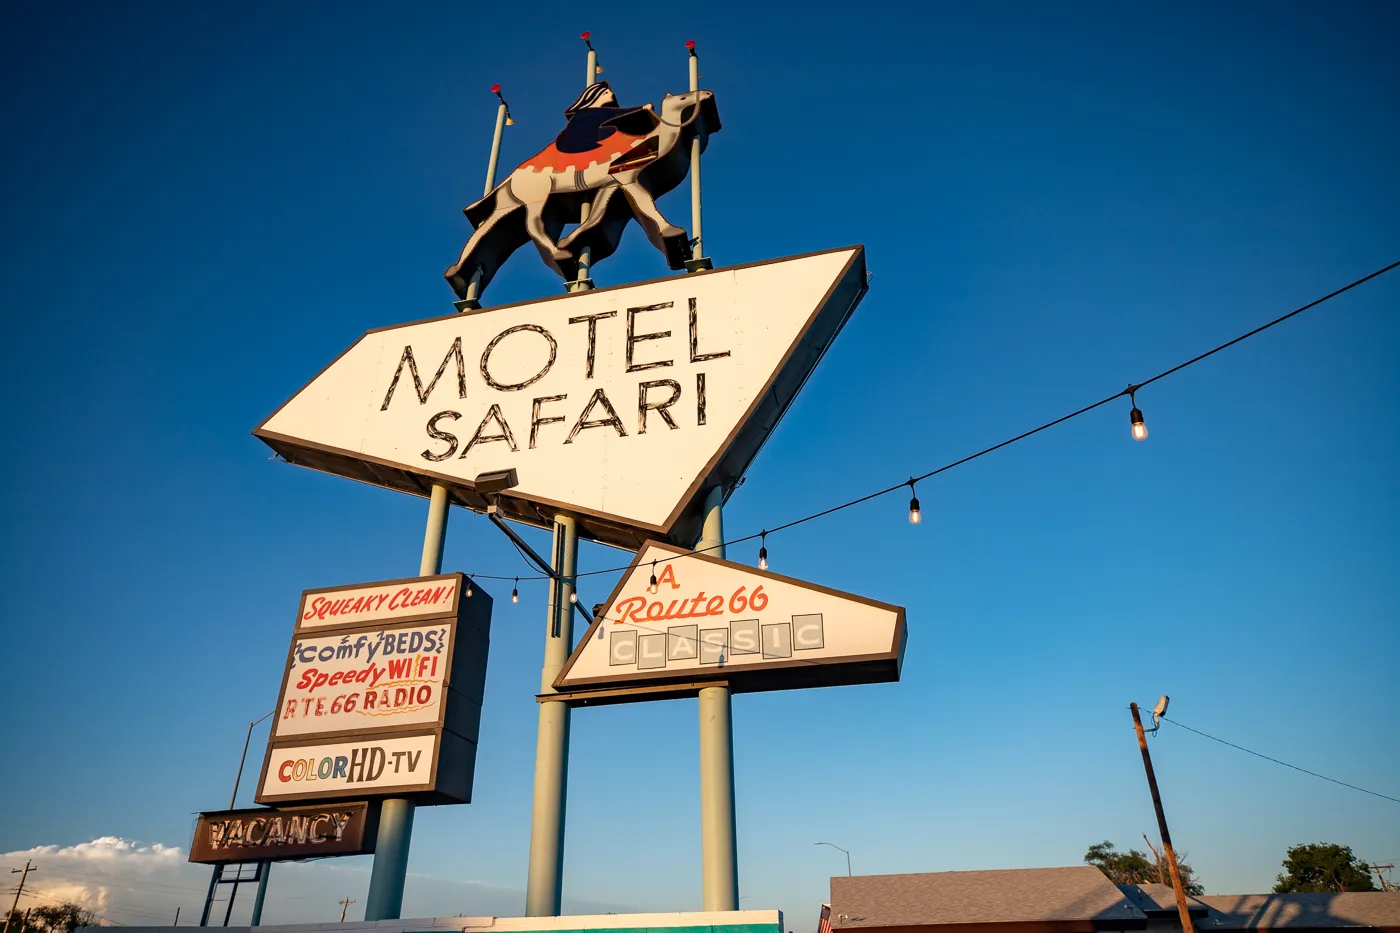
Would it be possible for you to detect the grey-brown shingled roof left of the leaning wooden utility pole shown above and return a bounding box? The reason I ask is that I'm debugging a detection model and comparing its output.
[832,866,1147,930]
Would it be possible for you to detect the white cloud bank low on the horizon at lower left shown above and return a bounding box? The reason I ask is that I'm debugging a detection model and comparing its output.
[0,836,627,926]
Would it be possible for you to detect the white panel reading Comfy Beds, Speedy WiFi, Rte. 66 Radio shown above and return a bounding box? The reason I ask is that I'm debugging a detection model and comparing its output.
[273,622,452,738]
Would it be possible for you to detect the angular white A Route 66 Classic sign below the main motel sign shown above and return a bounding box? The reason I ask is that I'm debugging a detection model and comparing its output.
[554,542,904,702]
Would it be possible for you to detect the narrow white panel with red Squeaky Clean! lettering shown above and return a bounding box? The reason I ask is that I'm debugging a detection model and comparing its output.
[297,573,462,632]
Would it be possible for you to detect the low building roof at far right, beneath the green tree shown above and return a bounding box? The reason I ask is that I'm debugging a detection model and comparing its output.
[1197,891,1400,933]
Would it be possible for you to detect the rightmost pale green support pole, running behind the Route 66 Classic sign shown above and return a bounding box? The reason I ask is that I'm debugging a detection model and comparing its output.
[696,486,739,911]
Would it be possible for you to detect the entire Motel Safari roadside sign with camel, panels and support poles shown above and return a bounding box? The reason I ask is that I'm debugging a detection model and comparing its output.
[224,32,904,925]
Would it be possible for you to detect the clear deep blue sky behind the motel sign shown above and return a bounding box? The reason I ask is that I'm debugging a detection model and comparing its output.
[0,3,1400,932]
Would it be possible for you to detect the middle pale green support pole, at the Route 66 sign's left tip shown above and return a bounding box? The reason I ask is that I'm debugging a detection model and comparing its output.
[525,514,578,916]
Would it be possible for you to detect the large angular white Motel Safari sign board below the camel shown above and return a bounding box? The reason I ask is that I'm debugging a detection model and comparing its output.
[253,247,865,551]
